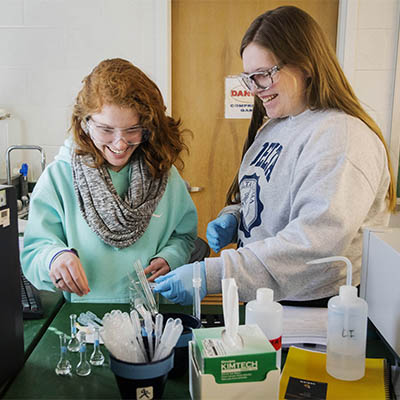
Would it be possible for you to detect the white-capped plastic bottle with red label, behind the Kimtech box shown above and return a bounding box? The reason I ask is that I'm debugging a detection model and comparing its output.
[245,288,283,369]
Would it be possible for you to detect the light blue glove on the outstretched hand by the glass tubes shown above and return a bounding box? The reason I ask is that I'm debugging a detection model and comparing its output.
[153,261,207,306]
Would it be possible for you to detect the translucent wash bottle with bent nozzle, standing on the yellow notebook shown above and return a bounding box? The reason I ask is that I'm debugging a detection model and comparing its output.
[310,257,368,381]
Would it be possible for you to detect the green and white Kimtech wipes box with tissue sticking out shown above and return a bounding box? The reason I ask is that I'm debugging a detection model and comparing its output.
[193,325,277,384]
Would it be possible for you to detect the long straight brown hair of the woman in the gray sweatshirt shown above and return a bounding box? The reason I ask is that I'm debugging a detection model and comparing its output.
[226,6,396,211]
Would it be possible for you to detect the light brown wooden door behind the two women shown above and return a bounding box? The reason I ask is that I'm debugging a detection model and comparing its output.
[171,0,338,250]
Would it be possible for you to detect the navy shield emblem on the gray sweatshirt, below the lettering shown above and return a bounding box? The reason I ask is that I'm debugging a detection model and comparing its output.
[239,174,264,237]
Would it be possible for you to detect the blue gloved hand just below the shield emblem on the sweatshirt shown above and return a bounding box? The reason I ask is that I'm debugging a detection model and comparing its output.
[206,214,238,253]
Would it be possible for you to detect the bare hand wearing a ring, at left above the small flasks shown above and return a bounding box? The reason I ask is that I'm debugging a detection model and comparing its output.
[50,251,90,296]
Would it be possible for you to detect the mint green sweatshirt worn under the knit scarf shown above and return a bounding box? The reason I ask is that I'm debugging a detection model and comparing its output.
[21,140,197,303]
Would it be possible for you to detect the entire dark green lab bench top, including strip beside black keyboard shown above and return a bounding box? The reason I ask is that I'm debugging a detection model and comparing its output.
[3,294,391,400]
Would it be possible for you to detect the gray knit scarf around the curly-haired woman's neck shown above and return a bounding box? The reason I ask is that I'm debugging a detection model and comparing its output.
[72,152,168,248]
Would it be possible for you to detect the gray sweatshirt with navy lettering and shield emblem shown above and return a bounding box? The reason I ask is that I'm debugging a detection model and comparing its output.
[206,110,390,301]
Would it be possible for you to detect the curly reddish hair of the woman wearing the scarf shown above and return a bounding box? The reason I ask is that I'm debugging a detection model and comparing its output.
[70,58,188,177]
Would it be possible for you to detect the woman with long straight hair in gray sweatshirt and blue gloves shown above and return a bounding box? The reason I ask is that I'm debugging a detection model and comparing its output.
[156,6,396,305]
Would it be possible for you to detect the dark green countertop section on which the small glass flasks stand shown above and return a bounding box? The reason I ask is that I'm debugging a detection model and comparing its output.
[4,303,222,399]
